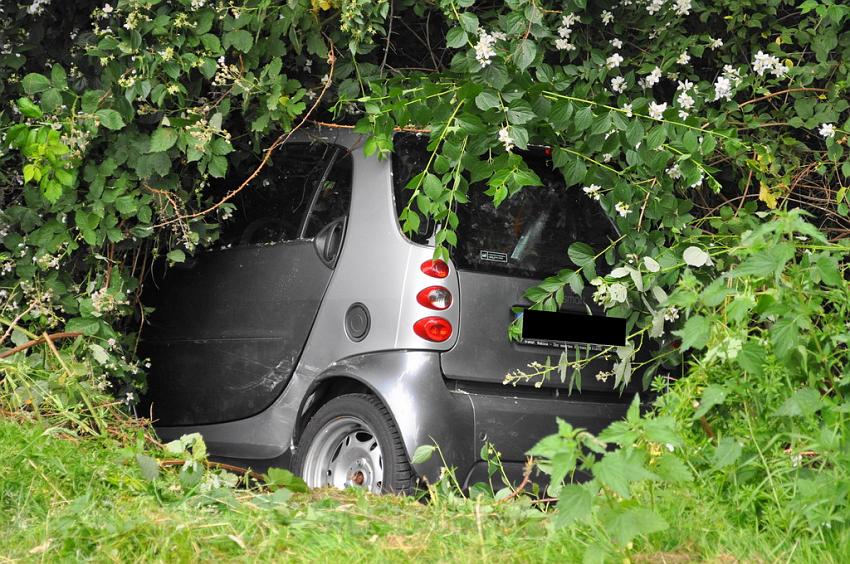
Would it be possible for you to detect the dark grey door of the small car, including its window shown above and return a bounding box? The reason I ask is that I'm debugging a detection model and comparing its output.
[143,143,352,425]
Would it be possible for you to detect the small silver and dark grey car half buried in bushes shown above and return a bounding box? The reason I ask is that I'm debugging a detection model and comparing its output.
[144,128,638,492]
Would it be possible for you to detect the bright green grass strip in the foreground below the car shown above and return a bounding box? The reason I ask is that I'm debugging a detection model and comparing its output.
[0,417,850,562]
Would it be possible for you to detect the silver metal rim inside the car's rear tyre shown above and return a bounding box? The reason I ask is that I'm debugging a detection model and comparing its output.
[303,415,384,493]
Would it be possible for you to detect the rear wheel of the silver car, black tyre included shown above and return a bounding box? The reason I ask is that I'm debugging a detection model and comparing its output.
[293,394,414,493]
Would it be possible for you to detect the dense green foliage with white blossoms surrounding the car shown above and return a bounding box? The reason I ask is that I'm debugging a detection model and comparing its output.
[0,0,850,555]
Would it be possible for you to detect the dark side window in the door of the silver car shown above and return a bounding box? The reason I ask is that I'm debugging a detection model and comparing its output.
[215,143,337,248]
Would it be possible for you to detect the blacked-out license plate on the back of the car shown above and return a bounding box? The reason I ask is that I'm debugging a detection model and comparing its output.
[520,309,626,348]
